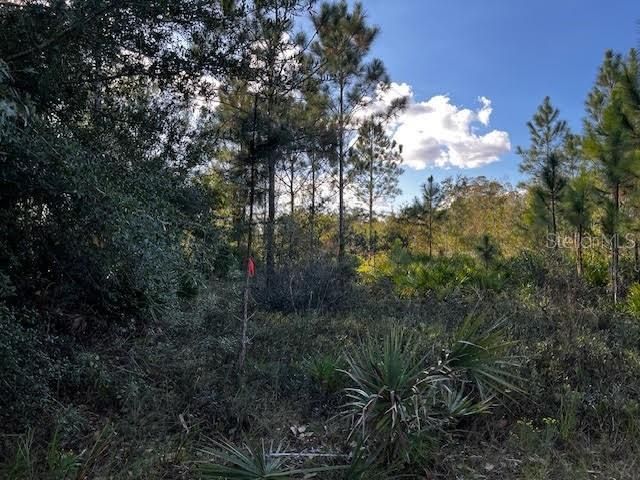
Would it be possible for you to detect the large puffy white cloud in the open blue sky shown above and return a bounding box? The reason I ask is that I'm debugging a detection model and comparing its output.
[367,83,511,170]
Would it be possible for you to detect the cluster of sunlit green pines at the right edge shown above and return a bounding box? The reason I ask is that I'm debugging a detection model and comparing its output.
[518,49,640,304]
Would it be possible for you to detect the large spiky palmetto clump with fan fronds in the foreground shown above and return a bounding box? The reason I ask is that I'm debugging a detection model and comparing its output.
[344,319,522,461]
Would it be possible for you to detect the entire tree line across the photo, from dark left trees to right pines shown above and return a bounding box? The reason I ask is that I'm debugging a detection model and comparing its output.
[0,0,640,338]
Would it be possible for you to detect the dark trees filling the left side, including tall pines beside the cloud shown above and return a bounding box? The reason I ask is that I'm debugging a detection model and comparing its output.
[0,0,404,332]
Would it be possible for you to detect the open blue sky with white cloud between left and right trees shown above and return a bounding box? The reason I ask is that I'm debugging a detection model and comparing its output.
[352,0,640,205]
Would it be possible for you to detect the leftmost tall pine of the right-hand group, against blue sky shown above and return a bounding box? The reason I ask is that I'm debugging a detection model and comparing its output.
[517,97,569,247]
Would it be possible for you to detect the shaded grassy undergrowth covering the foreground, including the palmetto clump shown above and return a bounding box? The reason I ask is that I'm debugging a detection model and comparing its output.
[2,272,640,480]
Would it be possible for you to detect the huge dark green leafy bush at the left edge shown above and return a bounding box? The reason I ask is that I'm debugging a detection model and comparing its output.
[0,56,228,331]
